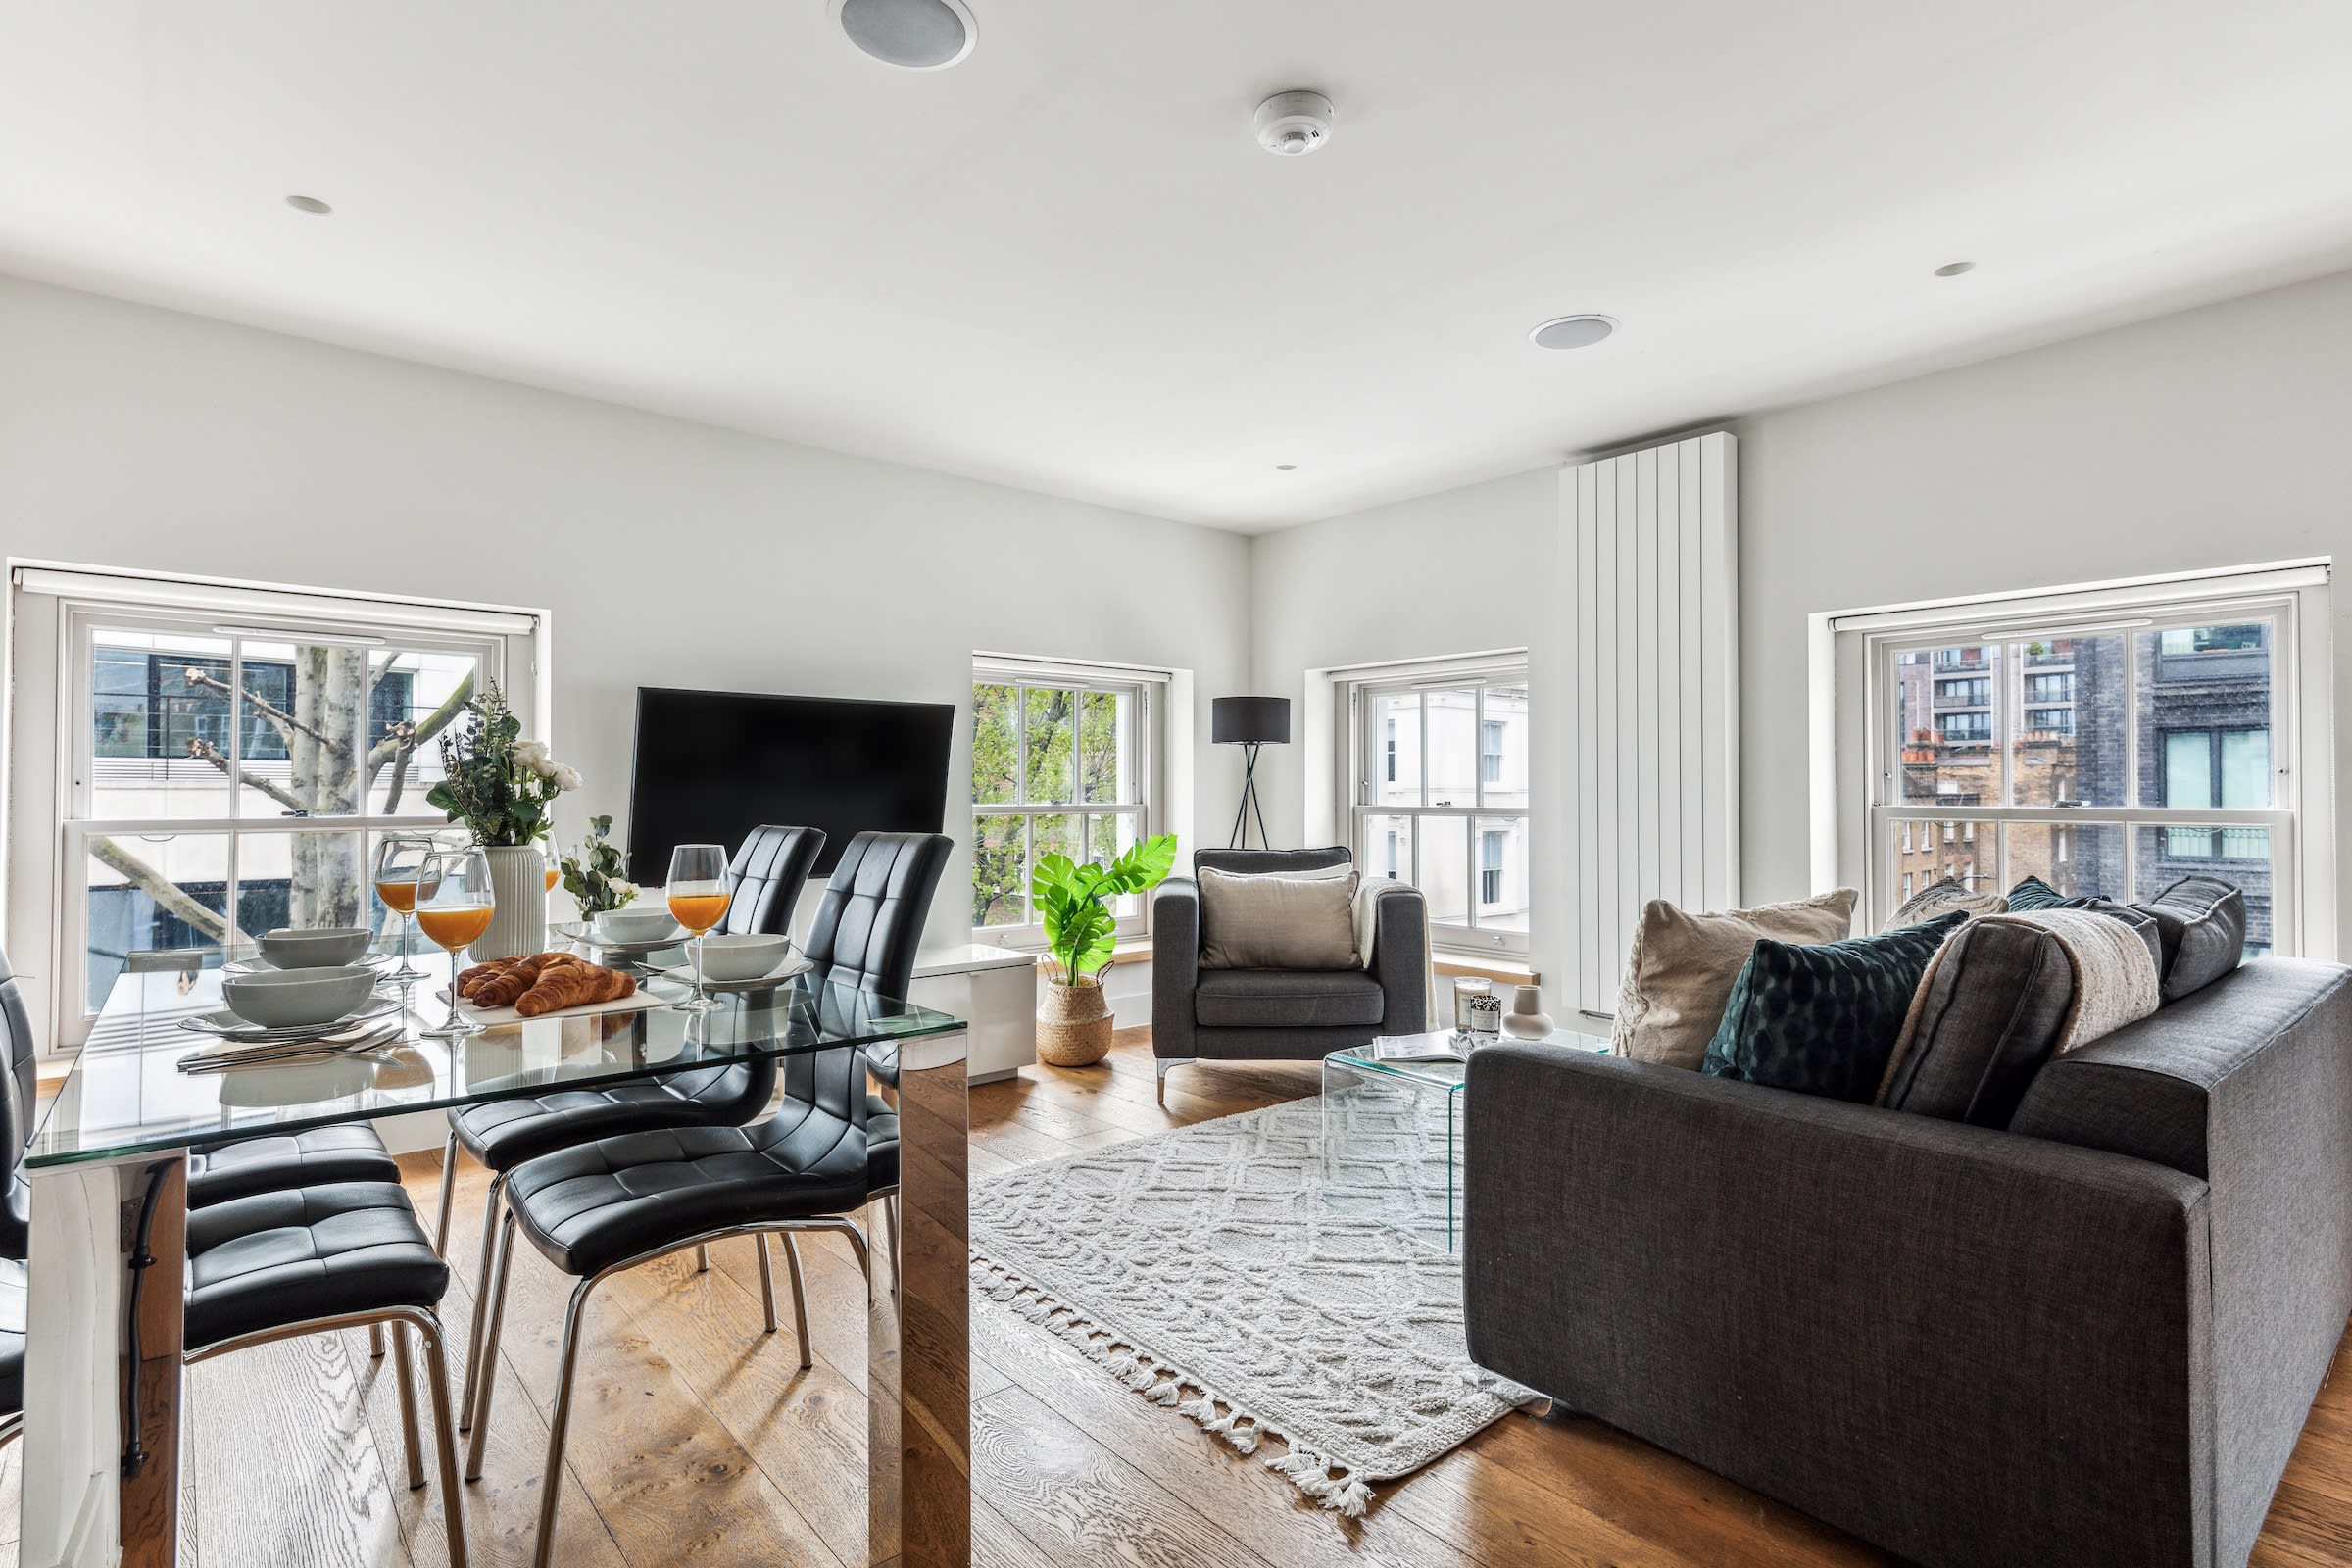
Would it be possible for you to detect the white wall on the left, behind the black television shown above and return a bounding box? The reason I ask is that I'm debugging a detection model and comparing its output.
[0,277,1249,1005]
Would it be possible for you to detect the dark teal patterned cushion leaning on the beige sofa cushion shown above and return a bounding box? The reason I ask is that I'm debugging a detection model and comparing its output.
[1698,909,1969,1104]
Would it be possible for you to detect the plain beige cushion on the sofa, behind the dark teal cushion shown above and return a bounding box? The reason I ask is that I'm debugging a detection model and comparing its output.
[1609,889,1856,1072]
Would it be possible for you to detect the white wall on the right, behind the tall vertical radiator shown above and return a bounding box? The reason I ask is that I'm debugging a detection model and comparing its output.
[1251,272,2352,1010]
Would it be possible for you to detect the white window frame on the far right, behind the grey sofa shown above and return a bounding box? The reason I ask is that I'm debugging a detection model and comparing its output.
[1813,562,2335,955]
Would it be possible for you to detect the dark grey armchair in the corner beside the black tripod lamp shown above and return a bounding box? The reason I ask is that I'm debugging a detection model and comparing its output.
[1152,847,1430,1102]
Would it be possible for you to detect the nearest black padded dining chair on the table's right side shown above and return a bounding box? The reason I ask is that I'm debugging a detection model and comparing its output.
[466,832,953,1568]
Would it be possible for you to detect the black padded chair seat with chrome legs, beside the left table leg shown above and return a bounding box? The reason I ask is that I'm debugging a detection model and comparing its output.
[186,1183,466,1568]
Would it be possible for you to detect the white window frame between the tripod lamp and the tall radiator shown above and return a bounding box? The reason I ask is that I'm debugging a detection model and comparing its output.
[1339,651,1541,956]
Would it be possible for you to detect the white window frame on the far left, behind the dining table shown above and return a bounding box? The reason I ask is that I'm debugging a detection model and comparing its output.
[7,564,548,1055]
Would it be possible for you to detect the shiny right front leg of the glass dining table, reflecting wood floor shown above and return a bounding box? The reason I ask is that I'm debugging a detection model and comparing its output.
[865,1034,971,1568]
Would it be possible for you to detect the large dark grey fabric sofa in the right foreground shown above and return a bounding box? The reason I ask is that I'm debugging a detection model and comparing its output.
[1463,959,2352,1568]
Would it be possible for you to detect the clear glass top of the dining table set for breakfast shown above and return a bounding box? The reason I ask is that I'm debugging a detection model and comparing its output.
[25,968,964,1168]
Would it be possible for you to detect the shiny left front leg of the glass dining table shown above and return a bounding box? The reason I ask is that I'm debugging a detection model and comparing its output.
[17,1156,188,1568]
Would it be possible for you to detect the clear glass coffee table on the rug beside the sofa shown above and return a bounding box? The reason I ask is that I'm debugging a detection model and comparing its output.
[1322,1030,1609,1253]
